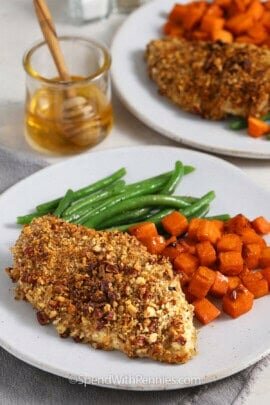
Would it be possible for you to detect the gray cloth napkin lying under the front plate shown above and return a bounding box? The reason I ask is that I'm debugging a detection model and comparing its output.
[0,149,270,405]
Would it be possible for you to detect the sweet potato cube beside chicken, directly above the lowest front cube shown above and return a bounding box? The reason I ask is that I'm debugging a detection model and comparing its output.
[188,266,216,298]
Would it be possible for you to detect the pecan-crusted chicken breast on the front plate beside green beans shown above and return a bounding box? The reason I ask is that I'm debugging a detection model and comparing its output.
[7,216,196,363]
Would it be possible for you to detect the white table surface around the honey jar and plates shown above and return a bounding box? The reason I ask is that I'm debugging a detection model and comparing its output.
[0,0,270,405]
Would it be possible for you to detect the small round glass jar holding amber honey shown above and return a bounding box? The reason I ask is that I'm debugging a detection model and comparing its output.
[23,36,113,155]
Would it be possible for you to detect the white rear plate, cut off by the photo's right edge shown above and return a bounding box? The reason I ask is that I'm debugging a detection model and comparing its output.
[111,0,270,159]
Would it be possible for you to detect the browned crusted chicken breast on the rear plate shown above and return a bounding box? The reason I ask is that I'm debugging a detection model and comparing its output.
[146,38,270,120]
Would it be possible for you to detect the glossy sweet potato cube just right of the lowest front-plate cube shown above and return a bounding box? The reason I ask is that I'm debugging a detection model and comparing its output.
[222,284,254,318]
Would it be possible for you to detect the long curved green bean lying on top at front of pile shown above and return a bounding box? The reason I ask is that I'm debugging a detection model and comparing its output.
[83,194,192,228]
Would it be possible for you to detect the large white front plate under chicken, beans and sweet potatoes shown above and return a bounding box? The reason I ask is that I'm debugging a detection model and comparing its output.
[0,146,270,390]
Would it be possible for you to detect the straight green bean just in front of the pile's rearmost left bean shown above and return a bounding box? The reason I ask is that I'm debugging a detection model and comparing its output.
[64,180,125,221]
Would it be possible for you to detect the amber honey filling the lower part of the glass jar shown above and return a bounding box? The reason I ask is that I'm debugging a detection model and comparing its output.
[25,77,113,154]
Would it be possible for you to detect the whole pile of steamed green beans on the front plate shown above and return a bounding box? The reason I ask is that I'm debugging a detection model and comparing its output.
[17,161,228,231]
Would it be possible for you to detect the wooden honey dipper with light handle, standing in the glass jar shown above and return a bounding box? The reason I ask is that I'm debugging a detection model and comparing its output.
[33,0,99,146]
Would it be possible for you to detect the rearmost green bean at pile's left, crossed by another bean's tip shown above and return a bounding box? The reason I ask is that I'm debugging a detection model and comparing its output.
[36,168,126,214]
